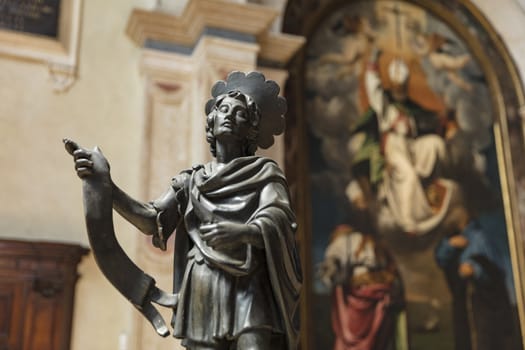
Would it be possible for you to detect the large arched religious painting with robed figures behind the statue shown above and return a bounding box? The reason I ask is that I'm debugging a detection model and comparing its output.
[284,1,523,350]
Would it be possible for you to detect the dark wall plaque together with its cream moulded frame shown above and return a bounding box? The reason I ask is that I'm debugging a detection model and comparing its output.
[0,0,82,92]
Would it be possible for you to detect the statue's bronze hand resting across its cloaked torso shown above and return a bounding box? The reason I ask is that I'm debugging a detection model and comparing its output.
[199,221,262,248]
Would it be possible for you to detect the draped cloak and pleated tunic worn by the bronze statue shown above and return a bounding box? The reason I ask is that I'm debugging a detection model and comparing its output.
[153,156,302,350]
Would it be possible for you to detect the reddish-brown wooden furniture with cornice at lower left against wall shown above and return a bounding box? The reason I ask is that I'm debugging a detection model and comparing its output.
[0,239,87,350]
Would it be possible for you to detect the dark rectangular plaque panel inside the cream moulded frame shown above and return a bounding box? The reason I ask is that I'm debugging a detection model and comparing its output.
[0,0,60,38]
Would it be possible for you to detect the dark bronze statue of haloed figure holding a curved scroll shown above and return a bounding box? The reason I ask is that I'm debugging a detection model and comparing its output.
[64,72,301,350]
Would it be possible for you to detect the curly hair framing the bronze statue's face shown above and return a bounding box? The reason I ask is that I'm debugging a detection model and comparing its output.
[206,90,261,157]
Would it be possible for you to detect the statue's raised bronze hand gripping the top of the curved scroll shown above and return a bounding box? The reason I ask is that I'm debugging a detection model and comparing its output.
[63,139,110,180]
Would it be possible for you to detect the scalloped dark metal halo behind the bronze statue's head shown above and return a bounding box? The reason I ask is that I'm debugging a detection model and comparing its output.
[205,72,287,148]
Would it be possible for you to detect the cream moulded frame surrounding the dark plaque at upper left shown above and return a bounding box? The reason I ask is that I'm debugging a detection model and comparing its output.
[0,0,82,92]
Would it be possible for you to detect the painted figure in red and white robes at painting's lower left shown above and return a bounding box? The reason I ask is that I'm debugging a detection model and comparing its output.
[320,220,406,350]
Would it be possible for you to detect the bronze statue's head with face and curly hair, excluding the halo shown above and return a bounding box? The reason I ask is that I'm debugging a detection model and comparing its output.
[206,90,261,156]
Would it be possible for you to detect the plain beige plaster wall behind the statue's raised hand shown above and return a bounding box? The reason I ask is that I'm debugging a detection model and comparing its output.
[0,0,155,350]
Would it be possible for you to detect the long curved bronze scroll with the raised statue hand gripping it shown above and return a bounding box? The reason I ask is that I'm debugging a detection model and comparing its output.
[63,139,177,336]
